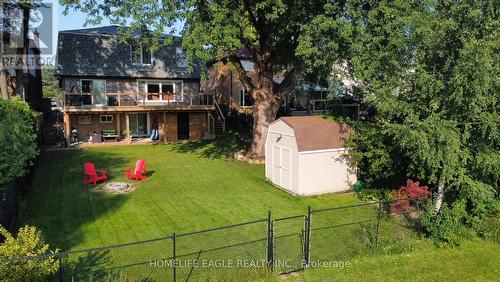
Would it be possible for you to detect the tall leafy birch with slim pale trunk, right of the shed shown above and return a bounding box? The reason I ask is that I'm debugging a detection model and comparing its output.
[301,0,500,212]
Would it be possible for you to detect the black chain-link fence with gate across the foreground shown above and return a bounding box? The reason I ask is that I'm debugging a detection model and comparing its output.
[0,199,412,281]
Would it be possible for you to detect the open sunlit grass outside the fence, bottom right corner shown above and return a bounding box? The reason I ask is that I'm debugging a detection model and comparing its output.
[287,239,500,281]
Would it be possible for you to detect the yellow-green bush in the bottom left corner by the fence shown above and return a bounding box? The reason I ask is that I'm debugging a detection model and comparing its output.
[0,226,59,281]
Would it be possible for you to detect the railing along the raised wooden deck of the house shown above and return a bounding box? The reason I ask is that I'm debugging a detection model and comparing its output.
[64,93,214,108]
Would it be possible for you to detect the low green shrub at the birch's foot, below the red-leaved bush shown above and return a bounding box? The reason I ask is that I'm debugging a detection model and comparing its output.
[420,201,470,246]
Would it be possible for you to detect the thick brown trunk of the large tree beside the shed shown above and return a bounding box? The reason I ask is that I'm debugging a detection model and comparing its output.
[247,85,279,158]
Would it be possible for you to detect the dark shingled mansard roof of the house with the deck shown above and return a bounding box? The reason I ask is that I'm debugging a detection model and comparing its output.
[56,26,200,79]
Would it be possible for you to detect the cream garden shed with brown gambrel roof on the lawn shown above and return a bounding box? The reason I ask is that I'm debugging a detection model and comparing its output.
[265,116,356,195]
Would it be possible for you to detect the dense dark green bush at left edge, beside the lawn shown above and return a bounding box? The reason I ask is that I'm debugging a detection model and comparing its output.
[0,99,38,186]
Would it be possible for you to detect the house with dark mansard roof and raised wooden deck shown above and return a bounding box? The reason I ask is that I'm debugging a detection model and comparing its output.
[55,26,221,142]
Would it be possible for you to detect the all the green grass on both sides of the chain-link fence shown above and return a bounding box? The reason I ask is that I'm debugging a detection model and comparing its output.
[21,136,500,281]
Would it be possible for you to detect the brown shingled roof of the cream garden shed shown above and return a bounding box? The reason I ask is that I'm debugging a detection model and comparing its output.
[275,116,351,152]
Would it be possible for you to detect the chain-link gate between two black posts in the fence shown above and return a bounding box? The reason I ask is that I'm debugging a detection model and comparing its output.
[272,215,307,273]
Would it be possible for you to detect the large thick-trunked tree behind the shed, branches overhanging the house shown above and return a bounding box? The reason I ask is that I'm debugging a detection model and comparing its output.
[59,0,352,157]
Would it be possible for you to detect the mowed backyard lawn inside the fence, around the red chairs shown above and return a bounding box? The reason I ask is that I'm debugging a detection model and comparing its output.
[21,137,359,249]
